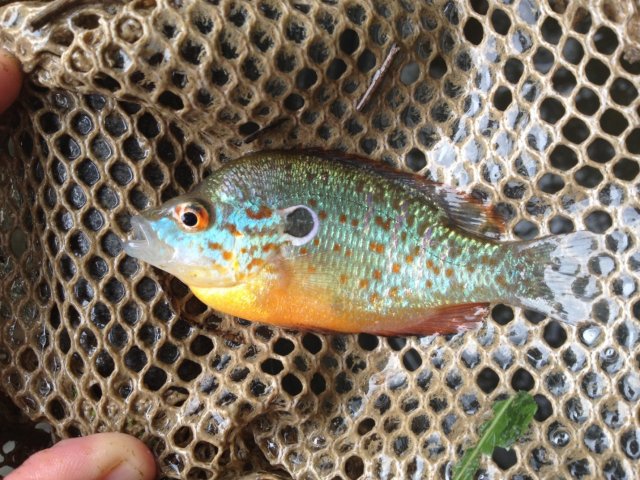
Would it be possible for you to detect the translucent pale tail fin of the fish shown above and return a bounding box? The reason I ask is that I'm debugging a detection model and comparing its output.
[513,232,602,324]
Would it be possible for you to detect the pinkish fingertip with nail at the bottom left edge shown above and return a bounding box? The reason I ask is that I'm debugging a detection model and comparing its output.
[6,433,156,480]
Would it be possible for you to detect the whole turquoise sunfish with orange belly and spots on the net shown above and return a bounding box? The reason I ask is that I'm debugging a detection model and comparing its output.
[124,151,602,335]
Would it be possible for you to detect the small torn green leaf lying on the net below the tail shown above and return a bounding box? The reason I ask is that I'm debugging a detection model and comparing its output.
[453,392,538,480]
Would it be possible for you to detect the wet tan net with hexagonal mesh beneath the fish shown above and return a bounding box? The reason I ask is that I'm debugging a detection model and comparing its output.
[0,0,640,479]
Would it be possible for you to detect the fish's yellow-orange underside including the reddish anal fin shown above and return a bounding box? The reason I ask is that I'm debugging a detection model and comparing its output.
[191,264,489,335]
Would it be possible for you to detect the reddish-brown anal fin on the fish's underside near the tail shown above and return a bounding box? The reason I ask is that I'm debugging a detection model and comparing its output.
[367,303,490,335]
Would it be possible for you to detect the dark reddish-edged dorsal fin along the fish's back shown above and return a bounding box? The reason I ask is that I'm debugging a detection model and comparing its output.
[264,149,505,240]
